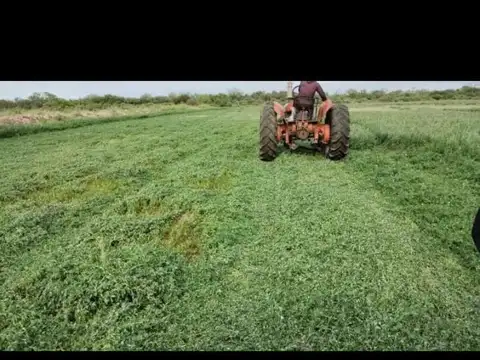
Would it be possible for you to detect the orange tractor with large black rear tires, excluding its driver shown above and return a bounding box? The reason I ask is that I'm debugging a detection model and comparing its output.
[260,82,350,161]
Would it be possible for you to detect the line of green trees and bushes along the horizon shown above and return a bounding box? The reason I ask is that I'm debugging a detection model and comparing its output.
[0,86,480,110]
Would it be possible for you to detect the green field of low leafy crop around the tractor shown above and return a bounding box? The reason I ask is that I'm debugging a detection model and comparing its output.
[0,105,480,350]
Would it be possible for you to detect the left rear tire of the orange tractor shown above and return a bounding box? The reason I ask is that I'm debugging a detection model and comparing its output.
[260,103,277,161]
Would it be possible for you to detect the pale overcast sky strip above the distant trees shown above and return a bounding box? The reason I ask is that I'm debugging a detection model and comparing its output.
[0,81,473,99]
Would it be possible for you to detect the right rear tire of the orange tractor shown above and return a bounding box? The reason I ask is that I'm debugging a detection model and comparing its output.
[325,105,350,161]
